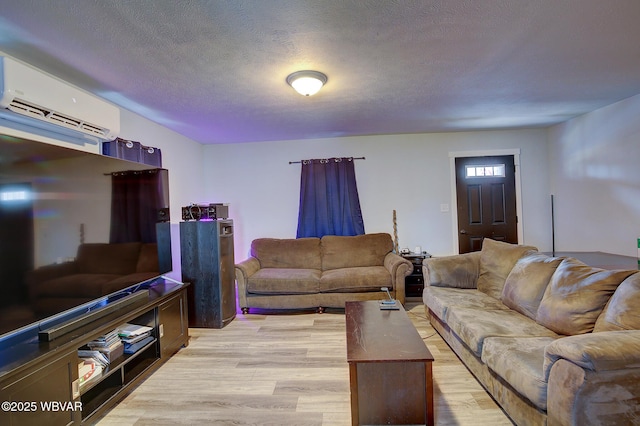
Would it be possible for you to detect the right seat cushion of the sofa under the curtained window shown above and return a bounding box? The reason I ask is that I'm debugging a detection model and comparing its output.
[320,266,391,292]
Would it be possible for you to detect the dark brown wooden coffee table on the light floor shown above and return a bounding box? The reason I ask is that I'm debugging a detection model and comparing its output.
[345,301,434,425]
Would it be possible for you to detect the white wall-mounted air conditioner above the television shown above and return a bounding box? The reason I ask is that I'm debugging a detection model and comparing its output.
[0,56,120,151]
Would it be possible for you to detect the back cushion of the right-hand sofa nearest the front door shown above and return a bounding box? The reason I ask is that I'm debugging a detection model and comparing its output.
[478,238,537,299]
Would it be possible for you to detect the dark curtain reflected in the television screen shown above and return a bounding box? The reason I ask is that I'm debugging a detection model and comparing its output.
[109,169,166,243]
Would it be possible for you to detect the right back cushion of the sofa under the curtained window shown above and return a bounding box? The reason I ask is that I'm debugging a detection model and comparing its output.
[320,233,393,271]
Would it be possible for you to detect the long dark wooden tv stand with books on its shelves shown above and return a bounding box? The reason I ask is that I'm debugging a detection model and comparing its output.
[0,279,189,425]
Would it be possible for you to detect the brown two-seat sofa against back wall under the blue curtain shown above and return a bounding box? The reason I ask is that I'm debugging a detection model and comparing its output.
[236,233,413,313]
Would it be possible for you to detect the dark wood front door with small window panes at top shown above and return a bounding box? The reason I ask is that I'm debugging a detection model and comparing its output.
[456,155,518,253]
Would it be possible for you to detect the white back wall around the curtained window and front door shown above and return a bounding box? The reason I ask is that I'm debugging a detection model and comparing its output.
[201,130,551,261]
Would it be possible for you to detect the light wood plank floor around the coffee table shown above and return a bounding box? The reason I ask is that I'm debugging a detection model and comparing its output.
[98,303,512,426]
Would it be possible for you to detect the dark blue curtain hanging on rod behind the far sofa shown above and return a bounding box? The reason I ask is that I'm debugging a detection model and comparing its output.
[297,158,364,238]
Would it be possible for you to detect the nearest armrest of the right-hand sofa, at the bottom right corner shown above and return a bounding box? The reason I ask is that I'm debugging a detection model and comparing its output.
[544,330,640,425]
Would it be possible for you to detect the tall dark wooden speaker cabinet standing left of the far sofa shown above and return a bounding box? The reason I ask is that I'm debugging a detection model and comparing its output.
[180,219,236,328]
